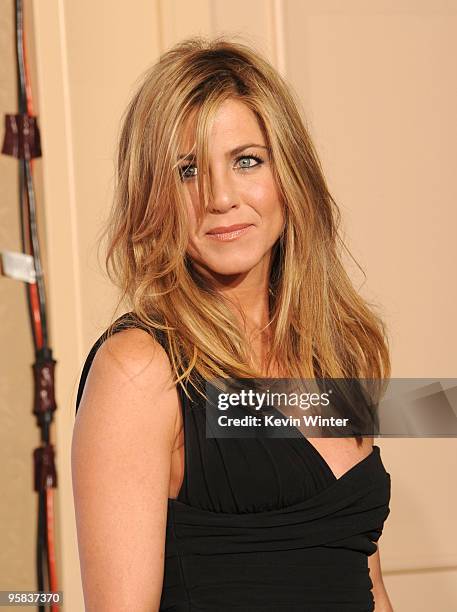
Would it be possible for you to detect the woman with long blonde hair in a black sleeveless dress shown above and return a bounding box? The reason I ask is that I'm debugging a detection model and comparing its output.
[72,38,392,612]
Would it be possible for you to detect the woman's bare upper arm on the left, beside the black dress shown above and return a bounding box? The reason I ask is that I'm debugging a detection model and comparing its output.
[71,329,179,612]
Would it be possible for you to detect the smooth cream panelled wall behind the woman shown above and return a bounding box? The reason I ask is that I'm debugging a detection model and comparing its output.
[0,0,457,612]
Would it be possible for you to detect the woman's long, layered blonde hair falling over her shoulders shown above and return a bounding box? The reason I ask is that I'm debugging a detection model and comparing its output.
[98,36,390,426]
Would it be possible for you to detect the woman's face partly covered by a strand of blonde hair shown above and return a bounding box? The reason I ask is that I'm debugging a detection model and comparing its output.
[179,99,284,283]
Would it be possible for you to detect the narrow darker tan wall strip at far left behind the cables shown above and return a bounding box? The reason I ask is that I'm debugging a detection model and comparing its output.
[0,0,61,610]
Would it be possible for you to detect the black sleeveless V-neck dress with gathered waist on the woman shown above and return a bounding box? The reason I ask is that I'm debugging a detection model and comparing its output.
[76,313,390,612]
